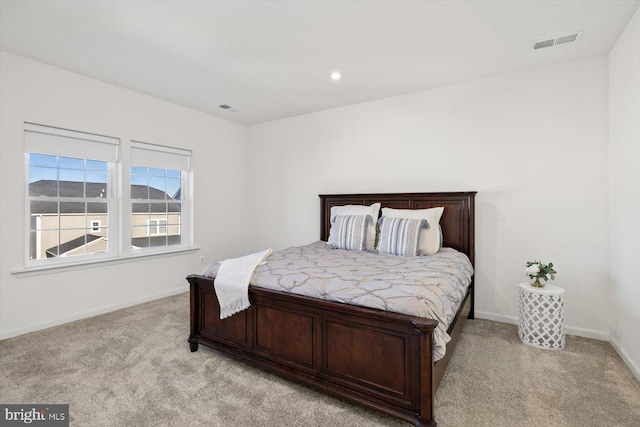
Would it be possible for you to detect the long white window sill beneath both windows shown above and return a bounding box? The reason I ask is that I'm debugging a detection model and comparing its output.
[11,247,200,278]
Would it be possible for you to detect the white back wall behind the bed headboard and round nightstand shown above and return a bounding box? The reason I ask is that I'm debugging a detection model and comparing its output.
[249,57,609,339]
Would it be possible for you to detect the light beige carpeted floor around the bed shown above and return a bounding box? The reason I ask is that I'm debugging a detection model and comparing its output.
[0,293,640,427]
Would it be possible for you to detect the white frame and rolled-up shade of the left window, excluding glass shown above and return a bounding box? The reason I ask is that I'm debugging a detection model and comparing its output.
[23,123,120,269]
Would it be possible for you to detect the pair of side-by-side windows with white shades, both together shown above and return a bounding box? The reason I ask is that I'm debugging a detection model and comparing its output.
[24,123,192,267]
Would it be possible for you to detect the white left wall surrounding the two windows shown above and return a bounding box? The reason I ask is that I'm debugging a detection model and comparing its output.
[0,52,248,338]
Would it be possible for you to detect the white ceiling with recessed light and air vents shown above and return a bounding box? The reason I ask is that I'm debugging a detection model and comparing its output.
[0,0,640,124]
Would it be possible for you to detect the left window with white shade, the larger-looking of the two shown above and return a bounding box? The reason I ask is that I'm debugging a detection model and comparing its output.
[25,124,119,264]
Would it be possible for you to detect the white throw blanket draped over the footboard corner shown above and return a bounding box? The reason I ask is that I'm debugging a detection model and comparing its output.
[213,249,271,319]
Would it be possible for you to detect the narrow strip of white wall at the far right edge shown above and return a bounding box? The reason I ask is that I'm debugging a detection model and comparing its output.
[609,10,640,380]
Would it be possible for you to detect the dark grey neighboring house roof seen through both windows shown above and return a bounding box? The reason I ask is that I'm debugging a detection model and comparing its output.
[29,180,180,215]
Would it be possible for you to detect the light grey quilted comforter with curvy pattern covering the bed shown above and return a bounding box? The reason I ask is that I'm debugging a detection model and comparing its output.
[203,241,473,360]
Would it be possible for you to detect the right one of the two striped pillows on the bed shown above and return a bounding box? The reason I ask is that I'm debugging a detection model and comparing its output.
[378,216,427,256]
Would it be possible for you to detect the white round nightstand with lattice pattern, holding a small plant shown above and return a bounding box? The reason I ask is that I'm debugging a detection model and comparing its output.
[518,282,565,350]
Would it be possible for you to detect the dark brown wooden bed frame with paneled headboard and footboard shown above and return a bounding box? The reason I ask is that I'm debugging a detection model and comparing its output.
[187,192,476,426]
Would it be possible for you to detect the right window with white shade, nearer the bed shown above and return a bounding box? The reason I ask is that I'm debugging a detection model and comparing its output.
[131,142,191,252]
